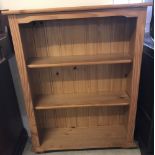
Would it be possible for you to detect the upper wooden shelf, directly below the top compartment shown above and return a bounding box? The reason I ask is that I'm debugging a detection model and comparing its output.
[27,54,132,68]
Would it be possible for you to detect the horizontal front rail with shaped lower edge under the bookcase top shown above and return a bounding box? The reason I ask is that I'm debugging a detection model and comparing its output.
[17,8,148,24]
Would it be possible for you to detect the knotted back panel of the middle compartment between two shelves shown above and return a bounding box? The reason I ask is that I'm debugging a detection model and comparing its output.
[29,64,131,96]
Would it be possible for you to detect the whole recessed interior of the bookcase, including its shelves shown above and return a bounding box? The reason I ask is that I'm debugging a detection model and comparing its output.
[20,17,136,149]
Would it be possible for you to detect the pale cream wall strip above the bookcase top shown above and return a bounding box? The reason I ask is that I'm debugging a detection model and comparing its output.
[0,0,149,10]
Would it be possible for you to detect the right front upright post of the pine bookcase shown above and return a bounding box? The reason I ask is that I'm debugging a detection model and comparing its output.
[127,9,146,143]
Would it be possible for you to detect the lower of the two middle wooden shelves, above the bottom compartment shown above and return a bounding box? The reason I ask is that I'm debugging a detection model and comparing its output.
[34,92,129,110]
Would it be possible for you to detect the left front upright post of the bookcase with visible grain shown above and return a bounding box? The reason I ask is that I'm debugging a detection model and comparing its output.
[9,15,40,147]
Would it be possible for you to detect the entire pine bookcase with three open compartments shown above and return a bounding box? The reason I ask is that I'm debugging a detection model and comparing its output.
[4,3,151,152]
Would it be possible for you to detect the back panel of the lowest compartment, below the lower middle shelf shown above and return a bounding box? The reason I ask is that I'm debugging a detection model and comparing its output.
[36,107,128,129]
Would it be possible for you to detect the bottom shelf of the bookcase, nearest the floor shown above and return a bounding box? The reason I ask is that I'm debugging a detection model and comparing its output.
[41,125,126,151]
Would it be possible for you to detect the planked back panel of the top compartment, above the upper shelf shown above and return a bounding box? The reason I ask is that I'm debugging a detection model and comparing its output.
[20,17,135,58]
